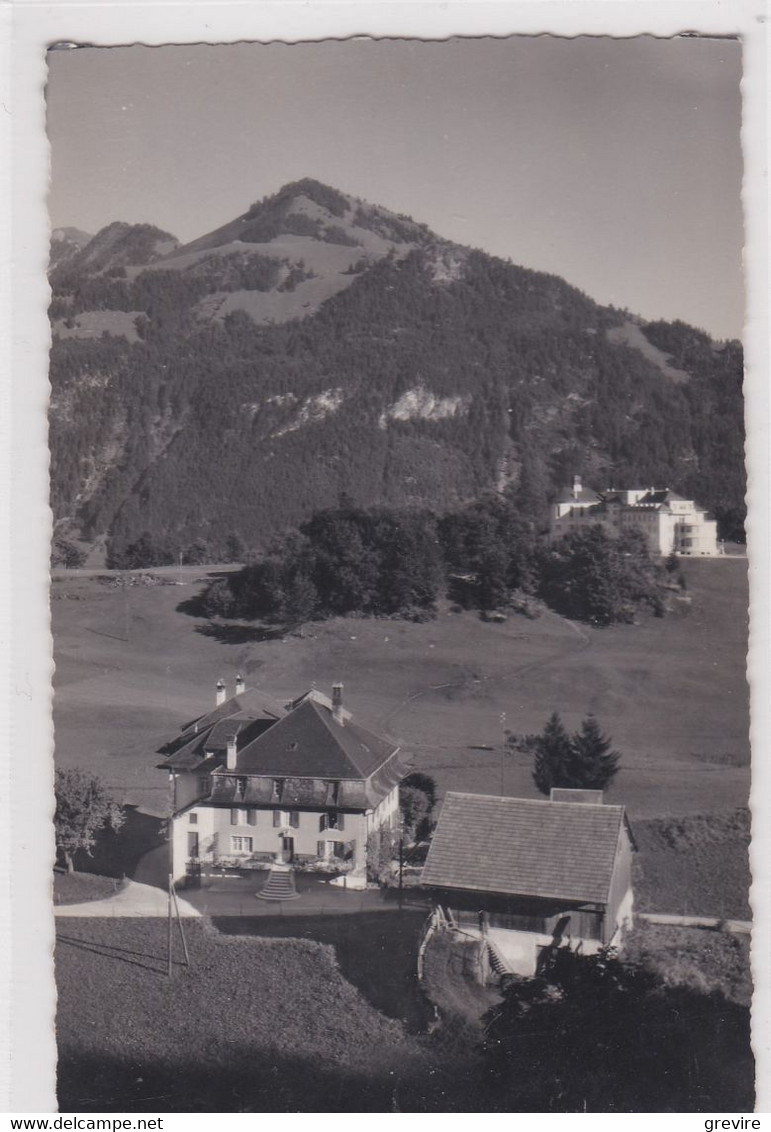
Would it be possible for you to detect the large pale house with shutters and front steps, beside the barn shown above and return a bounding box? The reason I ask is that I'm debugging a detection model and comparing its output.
[159,677,408,880]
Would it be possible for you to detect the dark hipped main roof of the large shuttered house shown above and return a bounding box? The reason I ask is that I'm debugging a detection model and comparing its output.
[237,698,397,779]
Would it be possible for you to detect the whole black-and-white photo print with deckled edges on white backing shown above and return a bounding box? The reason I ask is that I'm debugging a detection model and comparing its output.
[15,17,755,1114]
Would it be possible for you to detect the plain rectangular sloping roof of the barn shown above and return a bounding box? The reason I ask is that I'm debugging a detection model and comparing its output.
[422,792,624,903]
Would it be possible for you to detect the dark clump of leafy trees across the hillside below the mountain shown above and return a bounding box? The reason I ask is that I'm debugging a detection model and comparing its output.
[196,496,665,625]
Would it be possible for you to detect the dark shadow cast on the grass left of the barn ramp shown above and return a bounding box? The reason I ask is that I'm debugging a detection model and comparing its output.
[213,908,434,1034]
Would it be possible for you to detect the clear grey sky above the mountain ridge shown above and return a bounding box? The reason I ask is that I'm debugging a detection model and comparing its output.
[48,36,744,338]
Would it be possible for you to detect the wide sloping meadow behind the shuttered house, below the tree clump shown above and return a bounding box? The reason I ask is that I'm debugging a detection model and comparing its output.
[52,558,749,915]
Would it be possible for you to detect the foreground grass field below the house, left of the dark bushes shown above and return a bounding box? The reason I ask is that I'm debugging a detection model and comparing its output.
[57,919,480,1112]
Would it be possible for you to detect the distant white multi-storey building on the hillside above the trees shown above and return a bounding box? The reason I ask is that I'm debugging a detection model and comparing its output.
[550,475,721,557]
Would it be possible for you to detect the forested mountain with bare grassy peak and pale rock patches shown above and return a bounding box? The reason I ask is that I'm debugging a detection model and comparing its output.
[51,180,744,555]
